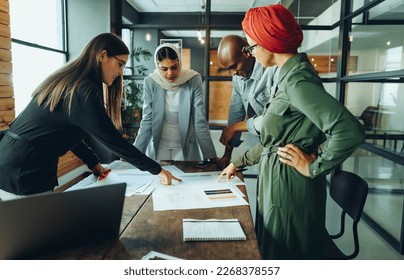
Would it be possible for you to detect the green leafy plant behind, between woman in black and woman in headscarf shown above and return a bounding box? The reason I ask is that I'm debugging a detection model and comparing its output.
[122,47,152,143]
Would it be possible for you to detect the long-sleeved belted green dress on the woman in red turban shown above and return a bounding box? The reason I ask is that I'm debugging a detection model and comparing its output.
[233,53,365,259]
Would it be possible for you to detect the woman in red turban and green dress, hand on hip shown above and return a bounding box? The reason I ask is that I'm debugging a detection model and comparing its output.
[220,5,365,259]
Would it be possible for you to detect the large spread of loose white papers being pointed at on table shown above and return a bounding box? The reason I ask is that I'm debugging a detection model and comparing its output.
[68,161,248,211]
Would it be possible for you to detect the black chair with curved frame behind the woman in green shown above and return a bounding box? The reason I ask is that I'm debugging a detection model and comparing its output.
[326,171,368,260]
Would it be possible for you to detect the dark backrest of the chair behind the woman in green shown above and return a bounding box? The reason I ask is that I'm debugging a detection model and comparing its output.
[330,171,368,222]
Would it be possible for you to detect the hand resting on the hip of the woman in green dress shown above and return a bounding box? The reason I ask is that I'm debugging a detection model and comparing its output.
[276,144,317,177]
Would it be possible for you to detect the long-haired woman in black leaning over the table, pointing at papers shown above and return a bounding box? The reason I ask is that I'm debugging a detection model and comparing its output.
[0,33,179,200]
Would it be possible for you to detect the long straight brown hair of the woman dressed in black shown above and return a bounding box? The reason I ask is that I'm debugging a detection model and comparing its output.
[32,33,129,130]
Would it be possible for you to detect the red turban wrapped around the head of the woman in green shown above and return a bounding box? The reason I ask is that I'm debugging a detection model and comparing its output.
[242,4,303,53]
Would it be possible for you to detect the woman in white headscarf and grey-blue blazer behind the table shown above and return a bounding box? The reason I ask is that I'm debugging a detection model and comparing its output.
[134,44,216,160]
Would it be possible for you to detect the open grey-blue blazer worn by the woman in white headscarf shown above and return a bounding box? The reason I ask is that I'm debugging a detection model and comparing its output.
[134,75,216,160]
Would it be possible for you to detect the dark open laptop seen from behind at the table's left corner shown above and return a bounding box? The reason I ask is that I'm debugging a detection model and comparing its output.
[0,183,126,259]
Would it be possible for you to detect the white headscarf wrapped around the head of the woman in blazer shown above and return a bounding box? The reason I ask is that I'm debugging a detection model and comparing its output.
[150,43,199,90]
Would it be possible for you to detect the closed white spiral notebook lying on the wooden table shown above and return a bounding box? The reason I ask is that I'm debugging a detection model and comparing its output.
[182,219,247,241]
